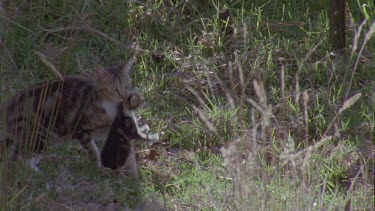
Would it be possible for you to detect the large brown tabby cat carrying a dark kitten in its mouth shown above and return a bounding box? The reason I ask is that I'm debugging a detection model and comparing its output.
[6,56,135,171]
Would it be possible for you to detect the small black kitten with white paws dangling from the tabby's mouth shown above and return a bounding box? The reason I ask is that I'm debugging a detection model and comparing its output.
[101,93,159,178]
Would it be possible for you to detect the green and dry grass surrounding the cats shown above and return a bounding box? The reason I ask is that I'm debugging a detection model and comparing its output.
[0,0,375,210]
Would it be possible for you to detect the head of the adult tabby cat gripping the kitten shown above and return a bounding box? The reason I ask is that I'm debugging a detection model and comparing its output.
[96,56,135,103]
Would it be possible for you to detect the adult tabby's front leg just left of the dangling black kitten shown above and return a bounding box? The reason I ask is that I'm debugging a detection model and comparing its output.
[73,130,101,167]
